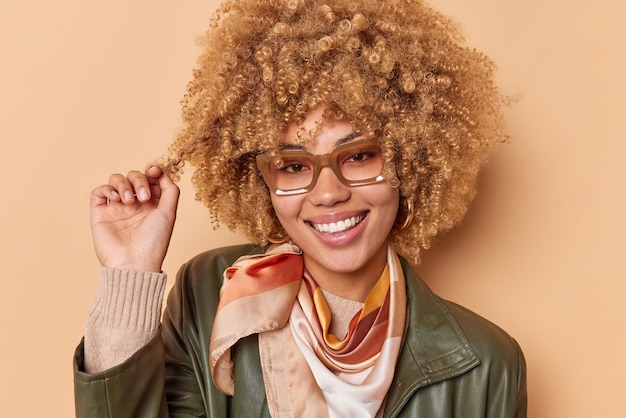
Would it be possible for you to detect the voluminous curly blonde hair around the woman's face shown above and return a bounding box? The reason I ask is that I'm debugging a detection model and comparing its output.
[163,0,505,263]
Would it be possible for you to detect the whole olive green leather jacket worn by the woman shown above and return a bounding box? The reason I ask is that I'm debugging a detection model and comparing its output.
[74,245,526,418]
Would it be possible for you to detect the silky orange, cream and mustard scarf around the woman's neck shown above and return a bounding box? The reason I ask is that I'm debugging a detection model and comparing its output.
[209,244,406,418]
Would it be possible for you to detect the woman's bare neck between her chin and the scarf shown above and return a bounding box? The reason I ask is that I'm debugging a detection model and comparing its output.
[303,246,387,302]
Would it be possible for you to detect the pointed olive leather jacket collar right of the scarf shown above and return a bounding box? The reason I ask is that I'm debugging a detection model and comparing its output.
[385,258,480,416]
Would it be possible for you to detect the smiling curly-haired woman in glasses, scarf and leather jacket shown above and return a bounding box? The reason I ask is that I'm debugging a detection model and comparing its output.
[75,0,526,418]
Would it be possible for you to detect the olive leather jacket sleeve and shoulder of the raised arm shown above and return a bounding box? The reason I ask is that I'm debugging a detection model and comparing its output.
[74,250,228,418]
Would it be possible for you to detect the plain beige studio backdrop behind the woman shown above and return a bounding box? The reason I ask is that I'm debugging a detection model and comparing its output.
[0,0,626,418]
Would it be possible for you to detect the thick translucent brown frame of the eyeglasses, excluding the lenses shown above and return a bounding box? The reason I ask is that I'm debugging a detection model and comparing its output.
[256,137,385,196]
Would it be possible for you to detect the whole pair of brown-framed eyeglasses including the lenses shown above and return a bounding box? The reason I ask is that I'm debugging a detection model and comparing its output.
[256,138,385,196]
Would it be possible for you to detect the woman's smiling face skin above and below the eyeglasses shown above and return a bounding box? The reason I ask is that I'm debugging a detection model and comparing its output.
[271,106,399,294]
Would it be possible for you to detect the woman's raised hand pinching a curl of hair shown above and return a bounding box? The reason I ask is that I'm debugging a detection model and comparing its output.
[90,167,180,272]
